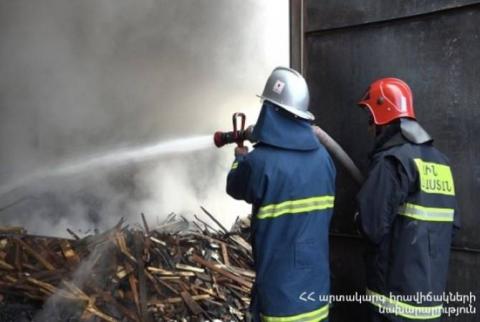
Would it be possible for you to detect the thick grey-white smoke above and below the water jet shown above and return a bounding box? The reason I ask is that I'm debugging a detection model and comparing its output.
[0,0,288,235]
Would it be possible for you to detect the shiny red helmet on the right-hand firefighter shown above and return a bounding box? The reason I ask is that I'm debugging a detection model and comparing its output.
[358,78,415,125]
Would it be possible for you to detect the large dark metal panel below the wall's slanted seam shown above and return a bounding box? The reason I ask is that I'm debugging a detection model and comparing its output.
[306,5,480,248]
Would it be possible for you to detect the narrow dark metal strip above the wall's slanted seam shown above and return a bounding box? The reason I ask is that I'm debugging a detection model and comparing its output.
[305,0,480,32]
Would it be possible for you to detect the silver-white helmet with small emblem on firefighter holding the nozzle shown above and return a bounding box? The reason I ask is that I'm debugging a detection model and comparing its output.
[260,67,315,120]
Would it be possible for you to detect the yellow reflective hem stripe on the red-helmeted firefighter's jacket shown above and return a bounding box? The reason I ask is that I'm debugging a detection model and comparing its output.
[367,289,443,320]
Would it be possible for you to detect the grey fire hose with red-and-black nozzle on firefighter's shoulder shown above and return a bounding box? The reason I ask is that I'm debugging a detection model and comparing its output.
[213,113,364,185]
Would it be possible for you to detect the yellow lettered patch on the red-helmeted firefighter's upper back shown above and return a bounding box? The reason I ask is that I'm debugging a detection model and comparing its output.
[413,159,455,196]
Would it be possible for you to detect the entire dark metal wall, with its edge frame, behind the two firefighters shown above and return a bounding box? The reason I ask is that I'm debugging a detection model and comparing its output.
[291,0,480,321]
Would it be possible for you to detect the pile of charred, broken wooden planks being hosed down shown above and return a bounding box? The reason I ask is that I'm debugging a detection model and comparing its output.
[0,209,255,322]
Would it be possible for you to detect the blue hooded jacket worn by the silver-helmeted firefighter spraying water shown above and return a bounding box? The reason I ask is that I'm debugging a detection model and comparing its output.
[227,101,336,322]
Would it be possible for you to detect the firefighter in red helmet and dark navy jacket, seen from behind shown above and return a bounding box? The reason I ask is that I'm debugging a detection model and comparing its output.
[356,78,459,322]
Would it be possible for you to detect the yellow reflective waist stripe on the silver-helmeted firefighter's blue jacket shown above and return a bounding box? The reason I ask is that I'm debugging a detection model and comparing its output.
[257,196,335,219]
